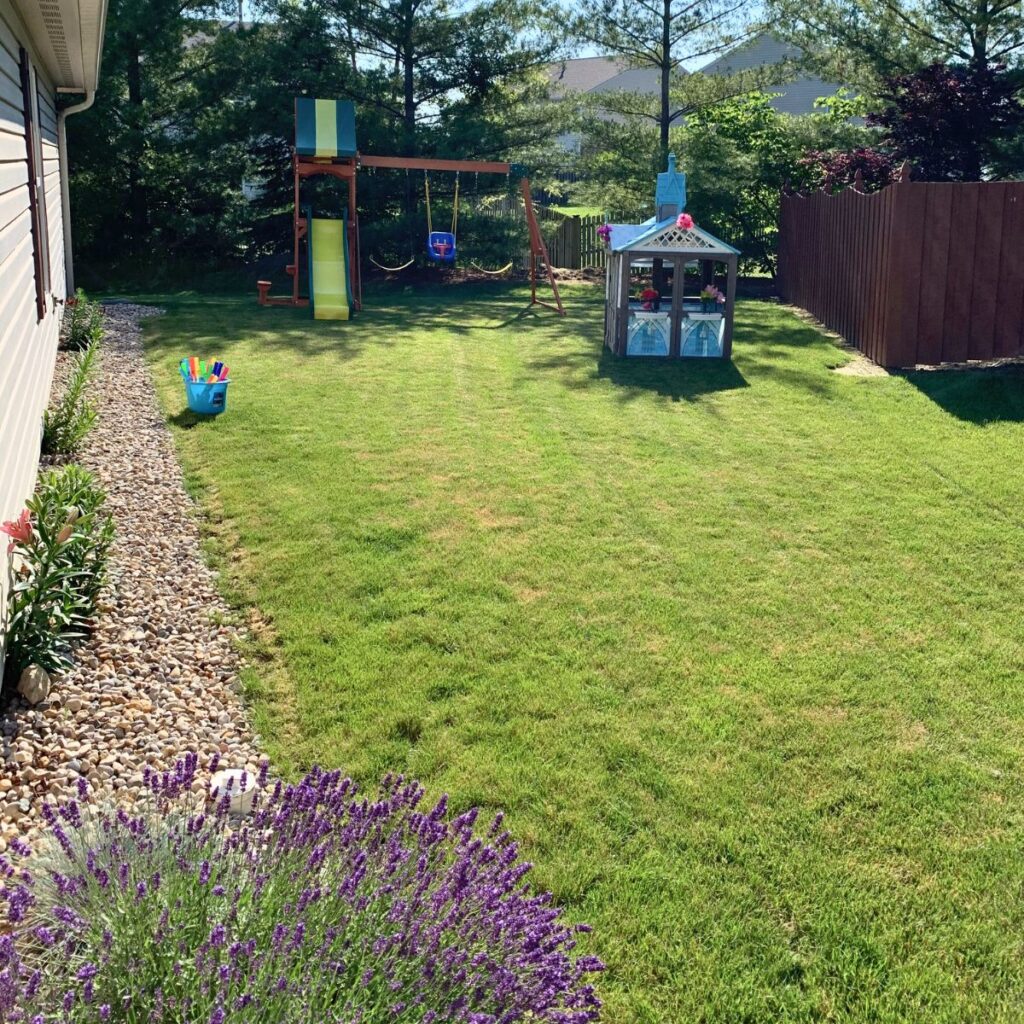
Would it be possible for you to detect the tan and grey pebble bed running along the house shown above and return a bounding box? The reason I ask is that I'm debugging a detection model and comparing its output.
[0,305,259,851]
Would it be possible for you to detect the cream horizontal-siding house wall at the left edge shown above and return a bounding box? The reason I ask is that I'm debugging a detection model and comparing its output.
[0,0,66,655]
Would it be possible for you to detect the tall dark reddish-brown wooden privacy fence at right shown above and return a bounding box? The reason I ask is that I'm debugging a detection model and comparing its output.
[778,174,1024,367]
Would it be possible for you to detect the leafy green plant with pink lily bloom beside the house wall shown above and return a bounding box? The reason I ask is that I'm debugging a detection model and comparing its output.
[0,466,114,681]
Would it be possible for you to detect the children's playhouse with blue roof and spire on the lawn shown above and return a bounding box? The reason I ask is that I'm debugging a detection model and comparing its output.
[604,156,739,359]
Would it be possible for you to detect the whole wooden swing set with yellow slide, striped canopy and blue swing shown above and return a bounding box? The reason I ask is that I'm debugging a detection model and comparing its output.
[256,97,565,319]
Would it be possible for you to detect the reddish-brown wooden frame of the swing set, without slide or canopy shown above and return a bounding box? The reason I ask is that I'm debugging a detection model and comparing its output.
[256,150,565,316]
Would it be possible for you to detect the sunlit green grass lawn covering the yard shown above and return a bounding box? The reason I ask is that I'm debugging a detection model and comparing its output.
[146,284,1024,1024]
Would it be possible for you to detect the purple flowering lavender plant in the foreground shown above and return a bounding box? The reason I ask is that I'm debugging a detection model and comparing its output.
[0,756,602,1024]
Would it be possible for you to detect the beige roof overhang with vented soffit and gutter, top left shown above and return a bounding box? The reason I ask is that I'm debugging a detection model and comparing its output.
[11,0,106,93]
